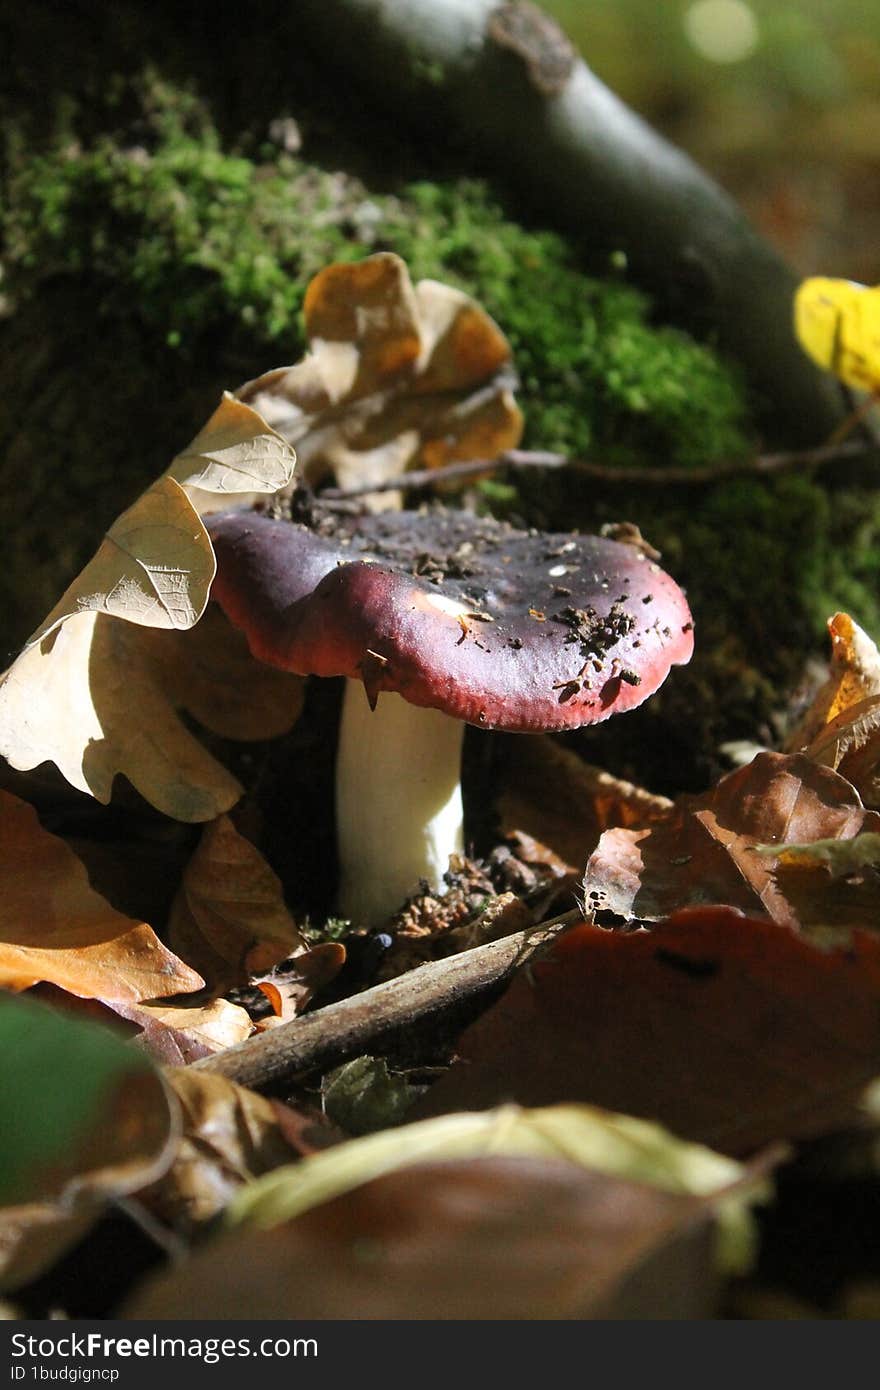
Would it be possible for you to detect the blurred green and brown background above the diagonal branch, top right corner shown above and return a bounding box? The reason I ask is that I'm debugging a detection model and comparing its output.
[542,0,880,284]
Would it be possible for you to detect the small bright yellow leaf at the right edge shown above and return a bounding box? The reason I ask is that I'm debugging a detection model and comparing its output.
[794,277,880,392]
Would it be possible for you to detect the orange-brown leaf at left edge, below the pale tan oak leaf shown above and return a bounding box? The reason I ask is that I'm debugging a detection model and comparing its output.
[0,792,203,1004]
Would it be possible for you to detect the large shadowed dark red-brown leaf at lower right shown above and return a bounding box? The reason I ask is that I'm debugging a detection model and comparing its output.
[413,908,880,1155]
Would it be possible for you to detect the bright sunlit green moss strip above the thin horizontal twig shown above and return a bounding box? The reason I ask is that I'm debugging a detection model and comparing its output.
[1,79,748,466]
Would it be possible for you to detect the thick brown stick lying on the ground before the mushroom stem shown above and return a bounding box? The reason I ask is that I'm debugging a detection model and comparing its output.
[190,912,582,1091]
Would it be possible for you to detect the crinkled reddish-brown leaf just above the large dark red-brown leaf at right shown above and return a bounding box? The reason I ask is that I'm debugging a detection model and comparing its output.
[584,753,880,930]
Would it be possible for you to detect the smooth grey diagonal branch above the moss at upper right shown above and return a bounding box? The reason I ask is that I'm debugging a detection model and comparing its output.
[296,0,848,443]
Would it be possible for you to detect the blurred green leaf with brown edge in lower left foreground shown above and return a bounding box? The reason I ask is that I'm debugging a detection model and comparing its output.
[0,998,179,1290]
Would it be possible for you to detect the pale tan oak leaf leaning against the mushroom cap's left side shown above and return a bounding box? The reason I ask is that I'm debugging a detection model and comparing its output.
[0,396,295,821]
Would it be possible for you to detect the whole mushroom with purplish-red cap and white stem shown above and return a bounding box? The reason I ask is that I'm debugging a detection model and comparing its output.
[207,509,694,924]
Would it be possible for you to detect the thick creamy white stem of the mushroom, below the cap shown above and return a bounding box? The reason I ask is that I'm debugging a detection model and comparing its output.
[336,680,464,926]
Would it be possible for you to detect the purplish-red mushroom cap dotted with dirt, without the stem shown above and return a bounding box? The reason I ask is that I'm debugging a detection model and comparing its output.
[207,512,694,733]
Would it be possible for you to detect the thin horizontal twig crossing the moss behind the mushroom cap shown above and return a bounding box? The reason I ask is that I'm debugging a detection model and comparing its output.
[320,439,876,502]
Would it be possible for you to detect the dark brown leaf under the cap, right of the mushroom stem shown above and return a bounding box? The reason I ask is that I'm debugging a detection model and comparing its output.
[496,734,671,873]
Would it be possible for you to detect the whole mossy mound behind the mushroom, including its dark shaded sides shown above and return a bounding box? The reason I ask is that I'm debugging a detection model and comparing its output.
[0,76,880,787]
